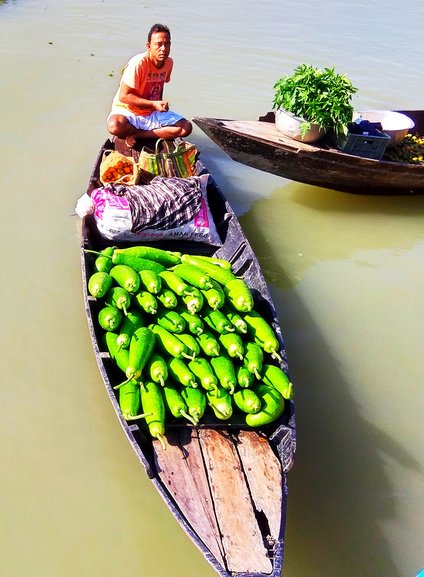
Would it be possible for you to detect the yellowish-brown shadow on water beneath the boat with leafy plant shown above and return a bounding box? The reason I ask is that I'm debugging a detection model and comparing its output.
[240,183,424,288]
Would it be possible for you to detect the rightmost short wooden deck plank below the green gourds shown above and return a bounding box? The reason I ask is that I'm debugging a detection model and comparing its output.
[237,431,283,541]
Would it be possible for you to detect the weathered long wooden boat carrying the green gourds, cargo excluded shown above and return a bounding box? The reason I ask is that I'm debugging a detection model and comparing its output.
[81,136,296,577]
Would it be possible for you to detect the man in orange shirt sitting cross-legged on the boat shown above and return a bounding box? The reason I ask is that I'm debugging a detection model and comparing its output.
[107,24,193,147]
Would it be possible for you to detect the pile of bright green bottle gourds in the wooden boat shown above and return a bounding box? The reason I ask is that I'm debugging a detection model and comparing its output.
[86,246,293,445]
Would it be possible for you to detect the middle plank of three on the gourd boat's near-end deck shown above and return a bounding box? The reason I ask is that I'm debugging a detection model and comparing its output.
[199,429,272,573]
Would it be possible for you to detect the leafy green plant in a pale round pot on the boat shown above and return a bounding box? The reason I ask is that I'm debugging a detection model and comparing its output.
[273,64,357,142]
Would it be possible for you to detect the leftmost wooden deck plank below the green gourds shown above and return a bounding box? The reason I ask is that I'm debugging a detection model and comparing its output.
[153,429,225,566]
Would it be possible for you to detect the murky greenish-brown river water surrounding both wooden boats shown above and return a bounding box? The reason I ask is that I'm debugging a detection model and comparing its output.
[0,0,424,577]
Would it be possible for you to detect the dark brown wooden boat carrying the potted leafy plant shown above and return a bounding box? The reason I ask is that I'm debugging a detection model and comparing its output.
[193,110,424,194]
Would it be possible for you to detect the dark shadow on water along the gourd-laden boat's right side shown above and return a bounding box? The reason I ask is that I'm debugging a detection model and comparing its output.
[274,284,422,577]
